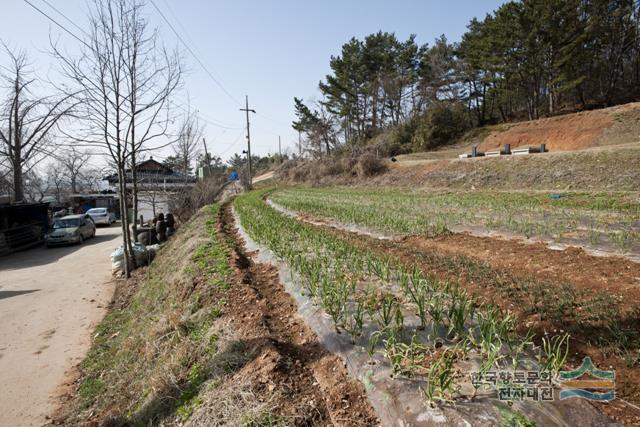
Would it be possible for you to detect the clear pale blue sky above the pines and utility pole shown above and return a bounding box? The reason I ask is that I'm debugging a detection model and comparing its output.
[0,0,504,159]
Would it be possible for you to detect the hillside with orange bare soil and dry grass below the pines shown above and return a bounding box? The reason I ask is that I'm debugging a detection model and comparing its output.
[276,103,640,191]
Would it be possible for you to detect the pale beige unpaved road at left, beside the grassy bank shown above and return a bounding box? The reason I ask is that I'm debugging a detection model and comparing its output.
[0,225,120,426]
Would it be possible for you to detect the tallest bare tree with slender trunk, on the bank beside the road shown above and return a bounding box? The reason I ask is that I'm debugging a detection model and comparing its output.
[53,0,181,277]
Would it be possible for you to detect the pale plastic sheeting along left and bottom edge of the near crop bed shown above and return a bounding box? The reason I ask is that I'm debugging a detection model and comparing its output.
[233,210,612,427]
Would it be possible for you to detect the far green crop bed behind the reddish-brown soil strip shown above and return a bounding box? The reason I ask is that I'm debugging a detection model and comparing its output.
[271,187,640,253]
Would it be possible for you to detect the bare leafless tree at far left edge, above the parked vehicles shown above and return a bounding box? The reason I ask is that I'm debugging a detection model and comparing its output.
[0,45,74,202]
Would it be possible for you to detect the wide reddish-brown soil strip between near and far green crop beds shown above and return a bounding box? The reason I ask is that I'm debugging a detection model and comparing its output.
[271,191,640,419]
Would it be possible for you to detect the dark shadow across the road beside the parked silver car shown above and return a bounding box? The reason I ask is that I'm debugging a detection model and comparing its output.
[0,227,120,271]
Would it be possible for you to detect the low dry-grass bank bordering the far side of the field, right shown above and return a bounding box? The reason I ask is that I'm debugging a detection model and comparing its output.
[380,149,640,191]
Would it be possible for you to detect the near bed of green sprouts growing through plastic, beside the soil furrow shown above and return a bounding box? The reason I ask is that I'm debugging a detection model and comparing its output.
[235,193,636,422]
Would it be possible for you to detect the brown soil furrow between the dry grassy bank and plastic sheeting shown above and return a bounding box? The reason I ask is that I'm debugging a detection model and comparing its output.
[220,206,379,426]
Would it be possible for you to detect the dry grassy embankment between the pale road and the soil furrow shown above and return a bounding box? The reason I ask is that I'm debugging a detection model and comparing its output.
[55,207,248,425]
